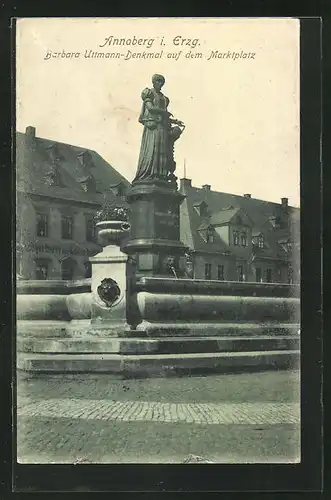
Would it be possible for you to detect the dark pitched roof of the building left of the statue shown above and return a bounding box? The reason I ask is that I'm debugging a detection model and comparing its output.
[16,132,130,204]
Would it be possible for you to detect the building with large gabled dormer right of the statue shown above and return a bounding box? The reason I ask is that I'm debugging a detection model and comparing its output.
[180,179,300,283]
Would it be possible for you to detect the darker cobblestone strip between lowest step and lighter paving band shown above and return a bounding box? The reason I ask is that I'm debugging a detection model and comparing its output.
[17,371,300,404]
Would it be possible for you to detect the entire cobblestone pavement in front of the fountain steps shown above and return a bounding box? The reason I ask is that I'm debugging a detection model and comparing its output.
[17,371,300,463]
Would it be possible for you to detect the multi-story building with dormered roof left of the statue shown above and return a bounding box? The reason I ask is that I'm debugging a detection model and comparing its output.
[16,127,130,279]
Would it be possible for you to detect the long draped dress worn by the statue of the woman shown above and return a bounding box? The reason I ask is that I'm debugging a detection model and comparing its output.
[134,89,169,181]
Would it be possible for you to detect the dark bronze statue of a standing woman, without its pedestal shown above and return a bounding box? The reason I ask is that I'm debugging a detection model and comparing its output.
[133,75,185,183]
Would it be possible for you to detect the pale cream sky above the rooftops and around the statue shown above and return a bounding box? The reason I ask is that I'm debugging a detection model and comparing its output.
[16,18,300,206]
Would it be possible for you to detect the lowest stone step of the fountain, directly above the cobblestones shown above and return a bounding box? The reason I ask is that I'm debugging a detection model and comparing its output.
[17,350,300,377]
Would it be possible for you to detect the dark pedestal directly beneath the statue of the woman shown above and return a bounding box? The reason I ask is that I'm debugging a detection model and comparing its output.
[124,180,187,278]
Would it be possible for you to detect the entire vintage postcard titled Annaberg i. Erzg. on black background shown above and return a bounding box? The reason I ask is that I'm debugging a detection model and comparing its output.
[15,18,301,464]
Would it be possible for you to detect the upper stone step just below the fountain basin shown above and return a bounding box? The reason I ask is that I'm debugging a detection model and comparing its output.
[17,335,300,355]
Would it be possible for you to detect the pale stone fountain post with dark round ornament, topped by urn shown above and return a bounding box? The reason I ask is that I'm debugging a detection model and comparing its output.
[90,221,130,334]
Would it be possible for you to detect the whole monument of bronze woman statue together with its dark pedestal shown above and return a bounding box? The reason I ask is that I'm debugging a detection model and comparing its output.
[123,75,186,278]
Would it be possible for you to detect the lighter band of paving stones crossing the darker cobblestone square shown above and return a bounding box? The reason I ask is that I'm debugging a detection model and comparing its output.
[17,399,300,425]
